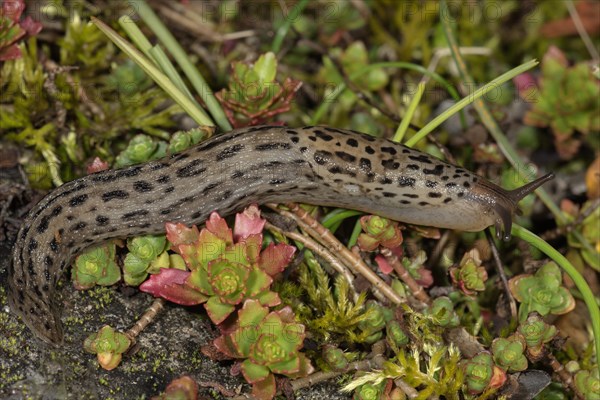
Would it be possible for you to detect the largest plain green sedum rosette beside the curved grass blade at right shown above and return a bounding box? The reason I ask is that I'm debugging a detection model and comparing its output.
[508,262,575,321]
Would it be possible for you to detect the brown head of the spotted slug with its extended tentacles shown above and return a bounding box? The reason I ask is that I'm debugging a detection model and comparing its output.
[472,173,554,241]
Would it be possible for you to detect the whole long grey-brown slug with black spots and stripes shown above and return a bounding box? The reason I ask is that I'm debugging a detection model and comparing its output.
[9,126,552,344]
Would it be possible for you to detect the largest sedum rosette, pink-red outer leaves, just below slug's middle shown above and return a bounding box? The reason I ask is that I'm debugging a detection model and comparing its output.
[140,206,296,324]
